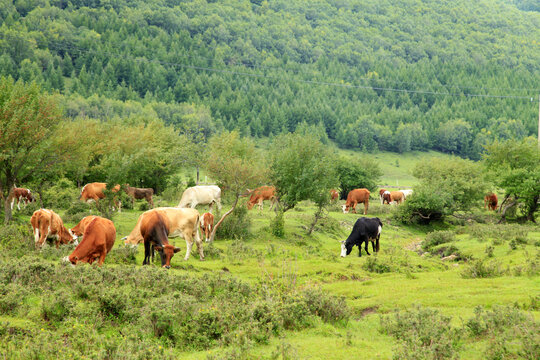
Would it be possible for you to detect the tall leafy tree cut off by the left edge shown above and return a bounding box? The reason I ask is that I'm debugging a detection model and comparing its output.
[0,77,77,223]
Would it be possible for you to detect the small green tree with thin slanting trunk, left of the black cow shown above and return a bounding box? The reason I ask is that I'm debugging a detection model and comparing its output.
[270,133,338,234]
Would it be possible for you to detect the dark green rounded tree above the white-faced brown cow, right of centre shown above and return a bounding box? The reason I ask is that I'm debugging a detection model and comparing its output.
[337,157,382,199]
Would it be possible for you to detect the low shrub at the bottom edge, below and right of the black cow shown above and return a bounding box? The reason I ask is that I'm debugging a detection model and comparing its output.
[381,306,461,359]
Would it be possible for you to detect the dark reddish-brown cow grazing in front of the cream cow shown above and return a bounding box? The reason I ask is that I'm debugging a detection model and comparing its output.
[141,211,181,269]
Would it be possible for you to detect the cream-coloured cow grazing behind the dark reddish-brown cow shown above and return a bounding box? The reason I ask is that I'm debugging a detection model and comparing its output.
[122,207,204,260]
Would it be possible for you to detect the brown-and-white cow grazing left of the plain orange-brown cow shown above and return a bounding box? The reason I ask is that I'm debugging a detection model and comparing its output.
[30,209,77,248]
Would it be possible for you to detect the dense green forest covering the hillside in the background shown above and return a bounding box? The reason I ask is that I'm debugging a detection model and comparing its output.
[0,0,540,158]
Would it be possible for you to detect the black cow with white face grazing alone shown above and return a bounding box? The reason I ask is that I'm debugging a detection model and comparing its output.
[341,218,382,257]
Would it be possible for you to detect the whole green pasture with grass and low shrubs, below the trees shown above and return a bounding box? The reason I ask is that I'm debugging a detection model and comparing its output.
[0,187,540,359]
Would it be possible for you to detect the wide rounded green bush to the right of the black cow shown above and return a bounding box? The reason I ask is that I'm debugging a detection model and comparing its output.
[398,158,487,223]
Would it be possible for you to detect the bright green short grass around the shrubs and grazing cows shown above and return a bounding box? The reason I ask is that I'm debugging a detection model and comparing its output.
[0,153,540,359]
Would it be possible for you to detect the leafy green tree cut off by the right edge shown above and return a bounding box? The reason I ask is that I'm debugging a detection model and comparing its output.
[484,138,540,222]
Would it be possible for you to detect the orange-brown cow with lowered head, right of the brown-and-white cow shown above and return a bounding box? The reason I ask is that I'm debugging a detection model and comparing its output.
[64,216,116,266]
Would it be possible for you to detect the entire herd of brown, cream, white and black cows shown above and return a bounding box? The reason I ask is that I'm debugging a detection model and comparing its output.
[8,183,497,268]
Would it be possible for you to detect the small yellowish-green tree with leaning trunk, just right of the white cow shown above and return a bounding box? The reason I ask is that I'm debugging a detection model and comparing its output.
[205,131,267,242]
